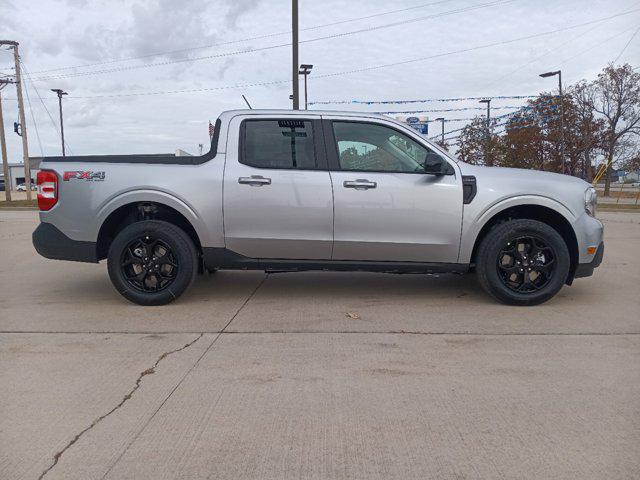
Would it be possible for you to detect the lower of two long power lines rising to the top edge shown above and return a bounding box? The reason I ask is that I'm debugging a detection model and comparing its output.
[34,0,518,81]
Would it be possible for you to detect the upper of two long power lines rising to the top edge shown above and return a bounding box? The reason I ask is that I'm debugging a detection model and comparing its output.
[32,0,457,74]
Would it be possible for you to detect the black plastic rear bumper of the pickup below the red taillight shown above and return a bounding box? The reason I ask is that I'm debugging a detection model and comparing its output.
[31,223,98,263]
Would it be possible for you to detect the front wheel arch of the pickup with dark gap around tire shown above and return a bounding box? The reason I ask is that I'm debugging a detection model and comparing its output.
[469,202,579,285]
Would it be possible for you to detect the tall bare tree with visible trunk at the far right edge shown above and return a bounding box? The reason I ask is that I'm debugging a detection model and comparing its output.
[593,64,640,196]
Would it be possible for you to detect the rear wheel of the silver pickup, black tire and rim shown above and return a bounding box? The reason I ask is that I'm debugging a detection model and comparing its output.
[107,220,198,305]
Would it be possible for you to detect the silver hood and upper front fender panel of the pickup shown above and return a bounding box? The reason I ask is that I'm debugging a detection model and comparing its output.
[458,162,590,216]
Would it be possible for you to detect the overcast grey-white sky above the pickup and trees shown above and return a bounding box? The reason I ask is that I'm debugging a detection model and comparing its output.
[0,0,640,162]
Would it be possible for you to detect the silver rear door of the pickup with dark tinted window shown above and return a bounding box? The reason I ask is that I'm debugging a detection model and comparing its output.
[223,115,333,260]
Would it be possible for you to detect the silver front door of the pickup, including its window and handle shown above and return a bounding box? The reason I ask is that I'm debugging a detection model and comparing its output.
[323,116,463,263]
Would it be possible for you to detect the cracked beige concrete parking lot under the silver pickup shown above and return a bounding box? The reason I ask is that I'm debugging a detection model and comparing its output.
[0,210,640,479]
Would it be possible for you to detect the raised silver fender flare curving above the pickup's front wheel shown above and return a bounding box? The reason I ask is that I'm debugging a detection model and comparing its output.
[458,195,577,263]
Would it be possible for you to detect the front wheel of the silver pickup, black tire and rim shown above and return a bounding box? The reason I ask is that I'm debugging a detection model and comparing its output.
[476,219,571,306]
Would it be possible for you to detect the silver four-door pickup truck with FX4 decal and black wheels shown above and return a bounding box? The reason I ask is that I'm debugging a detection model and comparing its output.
[33,110,604,305]
